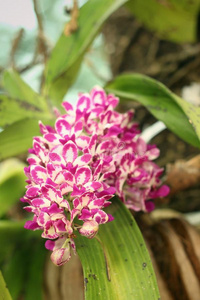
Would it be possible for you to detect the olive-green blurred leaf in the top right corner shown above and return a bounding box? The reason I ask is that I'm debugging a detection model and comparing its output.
[127,0,200,43]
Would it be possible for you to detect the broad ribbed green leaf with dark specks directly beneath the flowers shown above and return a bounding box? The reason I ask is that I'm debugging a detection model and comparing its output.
[76,198,159,300]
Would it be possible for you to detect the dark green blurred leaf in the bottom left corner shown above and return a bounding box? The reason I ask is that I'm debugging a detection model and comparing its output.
[0,221,47,300]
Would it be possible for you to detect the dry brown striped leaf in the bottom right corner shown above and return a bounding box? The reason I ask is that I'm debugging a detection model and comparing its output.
[143,216,200,300]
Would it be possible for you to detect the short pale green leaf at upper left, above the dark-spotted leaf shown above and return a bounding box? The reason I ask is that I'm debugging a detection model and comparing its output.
[3,70,48,112]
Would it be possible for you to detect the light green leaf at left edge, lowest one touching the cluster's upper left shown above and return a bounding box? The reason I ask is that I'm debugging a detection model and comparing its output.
[0,119,53,161]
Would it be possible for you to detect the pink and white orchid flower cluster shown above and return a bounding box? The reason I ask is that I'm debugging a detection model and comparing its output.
[22,88,169,265]
